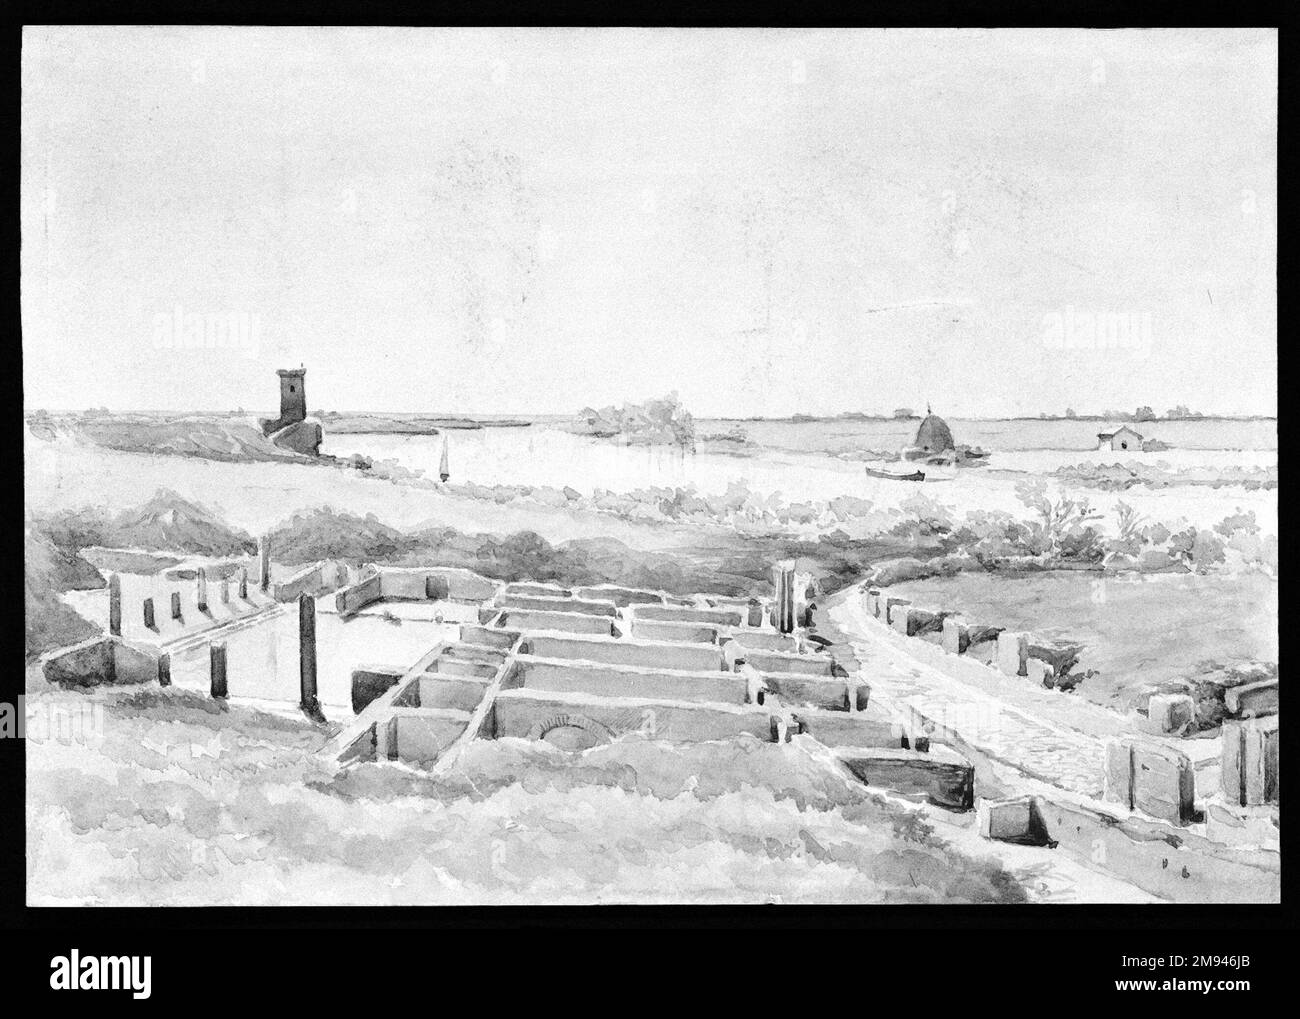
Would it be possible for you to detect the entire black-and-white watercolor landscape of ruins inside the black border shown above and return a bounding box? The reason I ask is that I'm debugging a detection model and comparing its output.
[22,26,1281,911]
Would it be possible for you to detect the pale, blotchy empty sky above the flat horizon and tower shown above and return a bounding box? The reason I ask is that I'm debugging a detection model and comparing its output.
[21,26,1277,417]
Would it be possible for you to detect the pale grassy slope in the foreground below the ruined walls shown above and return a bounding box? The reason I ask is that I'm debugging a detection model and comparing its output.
[27,688,1026,906]
